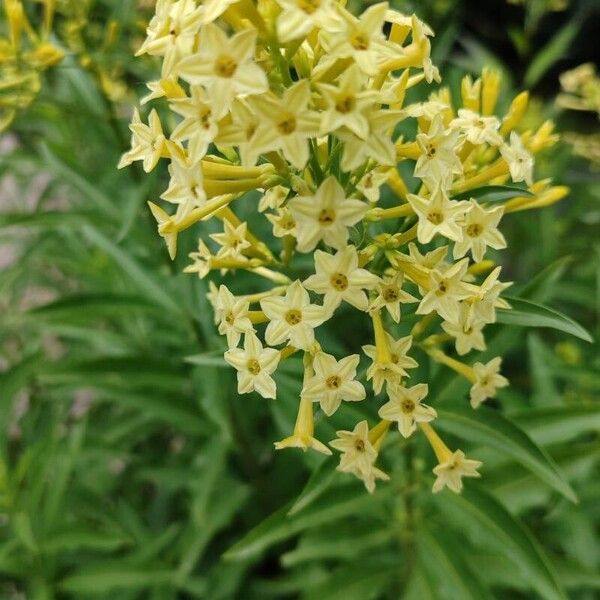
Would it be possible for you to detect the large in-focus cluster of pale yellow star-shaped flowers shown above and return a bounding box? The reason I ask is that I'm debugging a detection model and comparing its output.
[120,0,567,492]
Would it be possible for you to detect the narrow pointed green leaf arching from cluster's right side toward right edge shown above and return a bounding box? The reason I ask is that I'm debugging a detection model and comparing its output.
[496,296,594,343]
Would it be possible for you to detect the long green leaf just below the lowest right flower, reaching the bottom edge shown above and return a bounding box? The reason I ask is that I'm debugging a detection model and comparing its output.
[434,484,566,600]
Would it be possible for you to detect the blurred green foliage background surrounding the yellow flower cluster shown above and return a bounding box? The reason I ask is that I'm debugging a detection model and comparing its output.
[0,0,600,600]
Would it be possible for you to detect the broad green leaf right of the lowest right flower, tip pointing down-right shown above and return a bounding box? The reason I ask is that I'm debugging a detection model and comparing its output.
[436,406,577,502]
